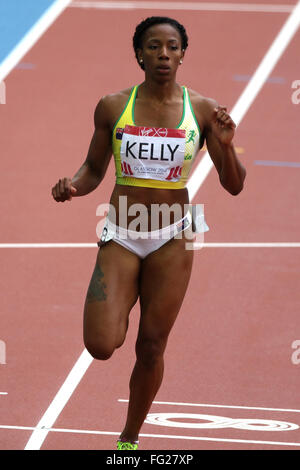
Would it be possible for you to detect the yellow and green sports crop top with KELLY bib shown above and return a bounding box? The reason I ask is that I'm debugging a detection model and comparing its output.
[112,85,203,189]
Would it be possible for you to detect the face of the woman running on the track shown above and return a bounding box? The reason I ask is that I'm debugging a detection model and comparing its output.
[138,23,184,78]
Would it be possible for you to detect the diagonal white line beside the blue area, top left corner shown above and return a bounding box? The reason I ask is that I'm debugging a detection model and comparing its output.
[0,0,72,82]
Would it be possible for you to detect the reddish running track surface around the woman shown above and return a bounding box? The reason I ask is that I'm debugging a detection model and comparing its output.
[0,1,300,450]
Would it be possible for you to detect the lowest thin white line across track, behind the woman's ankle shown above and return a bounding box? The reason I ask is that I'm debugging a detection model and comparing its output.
[0,425,300,447]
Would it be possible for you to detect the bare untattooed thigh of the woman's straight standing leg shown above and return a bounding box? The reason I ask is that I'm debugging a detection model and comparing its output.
[139,230,193,338]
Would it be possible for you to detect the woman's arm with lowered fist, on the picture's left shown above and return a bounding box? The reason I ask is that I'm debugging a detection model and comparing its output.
[52,98,112,202]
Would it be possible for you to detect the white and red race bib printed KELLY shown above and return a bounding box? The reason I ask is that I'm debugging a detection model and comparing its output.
[120,125,185,182]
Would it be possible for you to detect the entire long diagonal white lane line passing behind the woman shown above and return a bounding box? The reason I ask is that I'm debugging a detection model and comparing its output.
[25,1,300,450]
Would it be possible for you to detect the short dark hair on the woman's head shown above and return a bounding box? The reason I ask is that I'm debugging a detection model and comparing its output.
[133,16,188,70]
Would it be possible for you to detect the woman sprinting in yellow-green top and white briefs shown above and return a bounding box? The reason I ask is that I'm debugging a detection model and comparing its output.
[52,17,246,450]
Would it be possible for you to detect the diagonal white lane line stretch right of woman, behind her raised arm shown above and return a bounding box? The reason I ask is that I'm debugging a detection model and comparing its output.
[187,2,300,199]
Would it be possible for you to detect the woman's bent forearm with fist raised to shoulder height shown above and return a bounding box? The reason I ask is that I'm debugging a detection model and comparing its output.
[205,100,246,196]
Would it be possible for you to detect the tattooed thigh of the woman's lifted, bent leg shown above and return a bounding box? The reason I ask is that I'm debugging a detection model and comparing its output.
[84,241,140,348]
